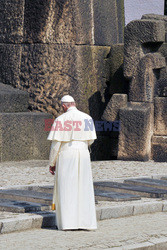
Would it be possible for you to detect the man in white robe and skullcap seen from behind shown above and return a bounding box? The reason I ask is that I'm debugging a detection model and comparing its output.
[48,95,97,230]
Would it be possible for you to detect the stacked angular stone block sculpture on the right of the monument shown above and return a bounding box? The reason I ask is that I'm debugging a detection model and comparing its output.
[102,14,167,161]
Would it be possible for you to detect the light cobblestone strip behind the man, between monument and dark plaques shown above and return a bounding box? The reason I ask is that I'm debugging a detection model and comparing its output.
[0,160,167,187]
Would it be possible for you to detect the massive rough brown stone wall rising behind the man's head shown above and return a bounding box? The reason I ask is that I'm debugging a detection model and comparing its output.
[0,0,124,119]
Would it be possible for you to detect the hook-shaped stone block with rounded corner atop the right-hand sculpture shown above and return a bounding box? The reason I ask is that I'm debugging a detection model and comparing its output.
[124,20,165,79]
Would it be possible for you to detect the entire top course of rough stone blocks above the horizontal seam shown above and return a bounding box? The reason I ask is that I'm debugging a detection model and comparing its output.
[0,0,124,45]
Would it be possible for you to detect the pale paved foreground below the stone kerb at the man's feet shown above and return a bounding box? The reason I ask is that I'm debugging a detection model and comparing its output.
[0,213,167,250]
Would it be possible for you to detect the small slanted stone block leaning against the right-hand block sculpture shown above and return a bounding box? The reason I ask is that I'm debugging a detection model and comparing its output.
[102,94,127,121]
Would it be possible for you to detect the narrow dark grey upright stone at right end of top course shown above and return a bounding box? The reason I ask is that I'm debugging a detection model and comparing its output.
[93,0,124,45]
